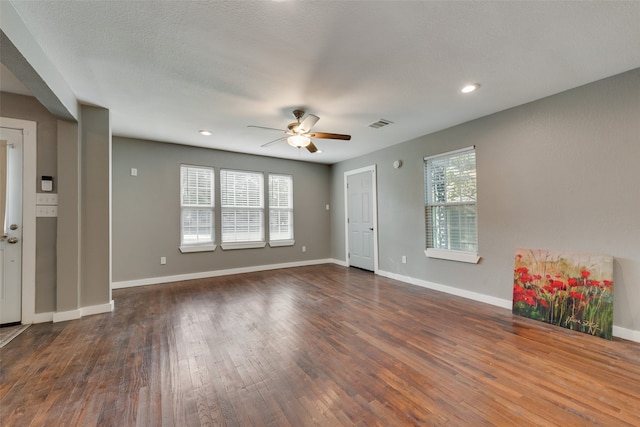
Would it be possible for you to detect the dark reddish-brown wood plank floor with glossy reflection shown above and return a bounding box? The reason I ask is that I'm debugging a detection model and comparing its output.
[0,265,640,426]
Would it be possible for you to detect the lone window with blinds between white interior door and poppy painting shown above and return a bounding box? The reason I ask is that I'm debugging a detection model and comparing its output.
[424,147,479,263]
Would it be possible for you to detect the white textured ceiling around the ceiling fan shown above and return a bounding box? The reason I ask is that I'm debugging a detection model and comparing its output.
[2,0,640,163]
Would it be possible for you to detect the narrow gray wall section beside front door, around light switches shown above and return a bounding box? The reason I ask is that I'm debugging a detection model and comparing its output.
[0,92,58,313]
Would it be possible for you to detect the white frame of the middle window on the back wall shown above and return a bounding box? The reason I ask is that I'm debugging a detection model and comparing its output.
[220,168,267,250]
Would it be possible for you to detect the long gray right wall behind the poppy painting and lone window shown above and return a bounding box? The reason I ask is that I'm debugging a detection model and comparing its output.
[331,69,640,331]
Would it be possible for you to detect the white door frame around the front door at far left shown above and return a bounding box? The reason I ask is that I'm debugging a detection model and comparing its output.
[0,117,38,325]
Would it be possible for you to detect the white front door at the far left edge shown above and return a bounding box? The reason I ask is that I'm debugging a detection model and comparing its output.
[0,127,23,325]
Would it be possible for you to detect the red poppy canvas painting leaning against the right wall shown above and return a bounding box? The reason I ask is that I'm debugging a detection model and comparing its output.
[513,248,613,339]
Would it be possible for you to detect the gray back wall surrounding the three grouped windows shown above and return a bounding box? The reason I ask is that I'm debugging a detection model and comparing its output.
[113,137,330,282]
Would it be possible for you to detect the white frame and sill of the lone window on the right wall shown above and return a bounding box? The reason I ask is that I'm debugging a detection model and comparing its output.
[424,146,480,264]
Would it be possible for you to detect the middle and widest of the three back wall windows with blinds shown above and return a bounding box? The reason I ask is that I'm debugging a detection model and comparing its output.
[220,169,265,249]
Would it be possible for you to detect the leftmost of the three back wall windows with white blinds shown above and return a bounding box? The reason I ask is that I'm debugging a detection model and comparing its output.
[180,165,215,252]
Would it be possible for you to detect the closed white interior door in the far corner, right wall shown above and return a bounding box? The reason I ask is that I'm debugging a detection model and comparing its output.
[346,170,376,271]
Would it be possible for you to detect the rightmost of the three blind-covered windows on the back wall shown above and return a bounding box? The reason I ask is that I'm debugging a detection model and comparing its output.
[269,175,295,246]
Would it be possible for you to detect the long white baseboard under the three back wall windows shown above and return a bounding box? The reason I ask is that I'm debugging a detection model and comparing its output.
[111,259,334,289]
